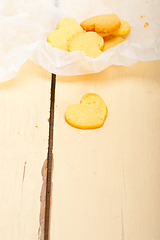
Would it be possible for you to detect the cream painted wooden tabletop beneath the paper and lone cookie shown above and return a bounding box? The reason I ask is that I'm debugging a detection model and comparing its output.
[0,1,160,240]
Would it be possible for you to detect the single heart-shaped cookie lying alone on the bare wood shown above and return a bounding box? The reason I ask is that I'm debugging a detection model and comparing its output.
[65,93,108,129]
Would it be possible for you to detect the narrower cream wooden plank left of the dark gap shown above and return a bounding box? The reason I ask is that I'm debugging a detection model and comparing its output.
[0,61,51,240]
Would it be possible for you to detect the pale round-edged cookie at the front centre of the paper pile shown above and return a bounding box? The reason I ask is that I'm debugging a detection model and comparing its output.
[69,32,104,58]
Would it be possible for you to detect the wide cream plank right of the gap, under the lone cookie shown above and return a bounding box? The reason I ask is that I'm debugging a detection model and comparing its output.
[50,61,160,240]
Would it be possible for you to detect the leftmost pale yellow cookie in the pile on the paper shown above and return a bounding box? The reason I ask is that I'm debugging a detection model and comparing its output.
[47,17,84,51]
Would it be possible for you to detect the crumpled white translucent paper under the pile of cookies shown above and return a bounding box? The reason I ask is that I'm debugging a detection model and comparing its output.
[0,0,160,82]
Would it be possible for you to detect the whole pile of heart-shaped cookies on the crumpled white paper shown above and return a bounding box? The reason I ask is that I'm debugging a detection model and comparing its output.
[47,14,131,58]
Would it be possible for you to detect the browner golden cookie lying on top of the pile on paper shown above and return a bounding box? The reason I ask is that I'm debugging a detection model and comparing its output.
[80,14,121,36]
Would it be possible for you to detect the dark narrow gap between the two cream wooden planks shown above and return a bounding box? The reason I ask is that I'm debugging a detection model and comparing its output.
[44,74,56,240]
